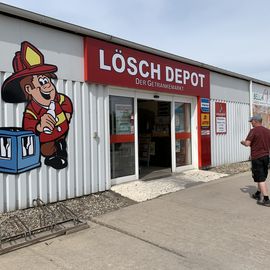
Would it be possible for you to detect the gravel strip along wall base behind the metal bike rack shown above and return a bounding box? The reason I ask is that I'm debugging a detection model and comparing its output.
[0,191,135,239]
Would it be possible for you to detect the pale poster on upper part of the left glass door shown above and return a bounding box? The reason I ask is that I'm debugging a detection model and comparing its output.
[115,104,132,134]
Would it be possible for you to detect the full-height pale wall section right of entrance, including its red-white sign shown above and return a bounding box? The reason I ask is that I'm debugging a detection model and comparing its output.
[210,71,250,166]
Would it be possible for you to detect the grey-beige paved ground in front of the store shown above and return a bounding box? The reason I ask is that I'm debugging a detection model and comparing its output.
[0,172,270,270]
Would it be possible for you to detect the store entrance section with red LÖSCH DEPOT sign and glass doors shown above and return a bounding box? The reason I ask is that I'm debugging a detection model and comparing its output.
[85,37,210,184]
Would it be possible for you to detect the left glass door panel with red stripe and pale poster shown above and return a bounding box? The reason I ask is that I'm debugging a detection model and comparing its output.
[110,96,135,179]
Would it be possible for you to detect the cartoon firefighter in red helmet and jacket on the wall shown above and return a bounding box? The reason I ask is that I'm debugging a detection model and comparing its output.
[1,41,73,169]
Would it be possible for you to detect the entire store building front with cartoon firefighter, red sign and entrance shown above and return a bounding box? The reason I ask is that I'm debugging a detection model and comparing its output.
[0,4,269,212]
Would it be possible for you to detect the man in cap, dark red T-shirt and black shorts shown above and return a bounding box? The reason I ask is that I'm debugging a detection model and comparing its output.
[241,115,270,206]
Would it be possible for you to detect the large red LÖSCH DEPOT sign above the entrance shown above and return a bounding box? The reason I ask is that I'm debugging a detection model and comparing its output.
[84,37,210,97]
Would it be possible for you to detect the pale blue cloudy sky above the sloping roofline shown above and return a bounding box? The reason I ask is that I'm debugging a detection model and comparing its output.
[2,0,270,82]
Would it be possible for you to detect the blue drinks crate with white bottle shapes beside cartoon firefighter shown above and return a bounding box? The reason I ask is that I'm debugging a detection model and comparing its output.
[0,127,41,174]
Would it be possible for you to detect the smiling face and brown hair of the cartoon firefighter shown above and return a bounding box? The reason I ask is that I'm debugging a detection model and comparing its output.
[20,74,56,106]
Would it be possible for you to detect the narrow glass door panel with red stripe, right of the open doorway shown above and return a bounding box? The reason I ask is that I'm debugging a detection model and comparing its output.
[175,102,192,167]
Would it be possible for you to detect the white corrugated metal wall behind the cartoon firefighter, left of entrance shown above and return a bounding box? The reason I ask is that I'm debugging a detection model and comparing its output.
[0,72,110,212]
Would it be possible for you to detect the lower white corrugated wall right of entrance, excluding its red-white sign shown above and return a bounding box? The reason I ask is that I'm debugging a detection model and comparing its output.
[210,99,250,166]
